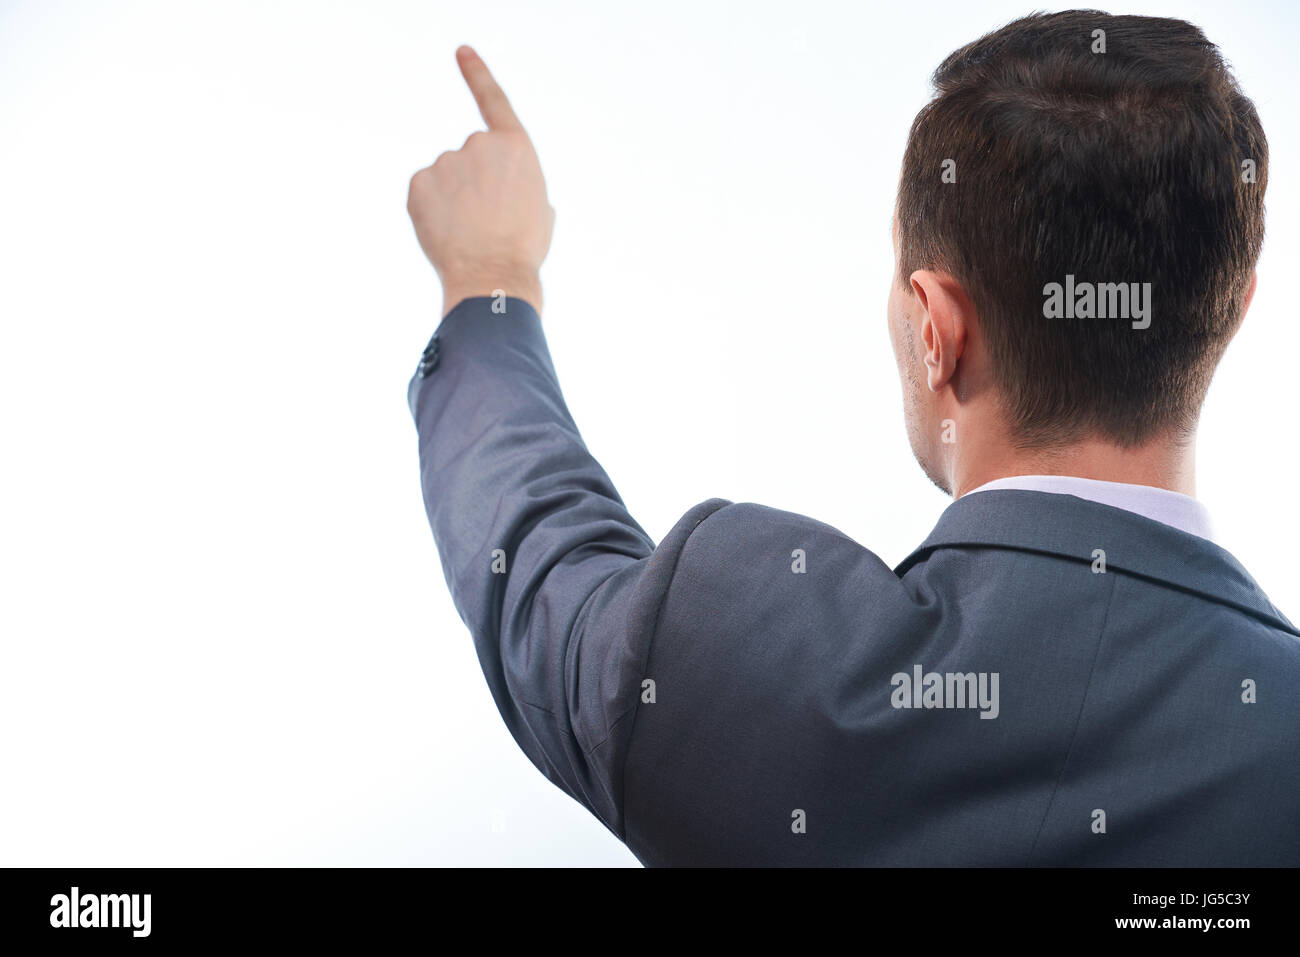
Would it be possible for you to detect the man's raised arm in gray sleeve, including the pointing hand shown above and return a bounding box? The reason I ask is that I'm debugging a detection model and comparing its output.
[408,48,724,837]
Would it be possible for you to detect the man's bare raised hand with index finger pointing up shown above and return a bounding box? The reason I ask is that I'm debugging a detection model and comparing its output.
[407,47,555,315]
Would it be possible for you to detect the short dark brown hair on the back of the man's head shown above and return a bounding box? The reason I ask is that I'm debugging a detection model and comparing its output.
[896,10,1269,447]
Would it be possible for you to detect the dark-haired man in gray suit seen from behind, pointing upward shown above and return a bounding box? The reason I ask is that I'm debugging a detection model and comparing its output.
[408,10,1300,866]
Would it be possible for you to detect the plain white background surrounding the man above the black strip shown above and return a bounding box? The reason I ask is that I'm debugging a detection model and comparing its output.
[0,0,1300,866]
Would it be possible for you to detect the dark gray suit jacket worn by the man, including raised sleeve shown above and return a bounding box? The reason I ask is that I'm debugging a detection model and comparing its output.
[408,298,1300,866]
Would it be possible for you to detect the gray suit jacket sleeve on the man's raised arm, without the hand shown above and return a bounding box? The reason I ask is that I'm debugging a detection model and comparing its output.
[407,296,728,837]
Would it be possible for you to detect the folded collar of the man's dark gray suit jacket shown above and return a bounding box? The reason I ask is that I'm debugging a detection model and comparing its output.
[894,489,1300,635]
